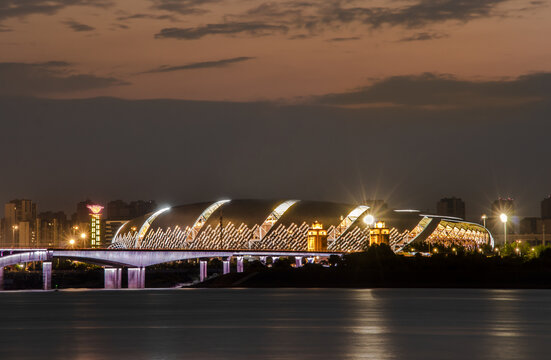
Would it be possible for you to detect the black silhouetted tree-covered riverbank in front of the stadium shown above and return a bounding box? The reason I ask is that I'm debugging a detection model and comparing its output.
[196,248,551,289]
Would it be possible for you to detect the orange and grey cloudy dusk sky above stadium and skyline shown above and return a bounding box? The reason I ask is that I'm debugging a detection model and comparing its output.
[0,0,551,219]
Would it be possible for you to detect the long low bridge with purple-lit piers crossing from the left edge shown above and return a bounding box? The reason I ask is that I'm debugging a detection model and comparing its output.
[0,248,343,290]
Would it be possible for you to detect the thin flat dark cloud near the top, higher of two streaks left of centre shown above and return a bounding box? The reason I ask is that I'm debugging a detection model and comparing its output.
[155,22,288,40]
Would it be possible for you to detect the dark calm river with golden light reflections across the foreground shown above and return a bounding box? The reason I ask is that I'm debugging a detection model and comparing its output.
[0,289,551,360]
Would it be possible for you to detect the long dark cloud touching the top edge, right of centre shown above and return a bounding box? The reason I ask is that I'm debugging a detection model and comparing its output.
[211,0,510,40]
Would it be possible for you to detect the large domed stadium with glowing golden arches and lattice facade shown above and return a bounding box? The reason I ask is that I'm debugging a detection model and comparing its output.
[110,200,494,252]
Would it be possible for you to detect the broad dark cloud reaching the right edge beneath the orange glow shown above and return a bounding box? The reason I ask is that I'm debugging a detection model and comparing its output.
[316,73,551,108]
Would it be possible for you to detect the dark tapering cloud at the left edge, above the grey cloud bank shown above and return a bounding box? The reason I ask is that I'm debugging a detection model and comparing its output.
[0,61,127,96]
